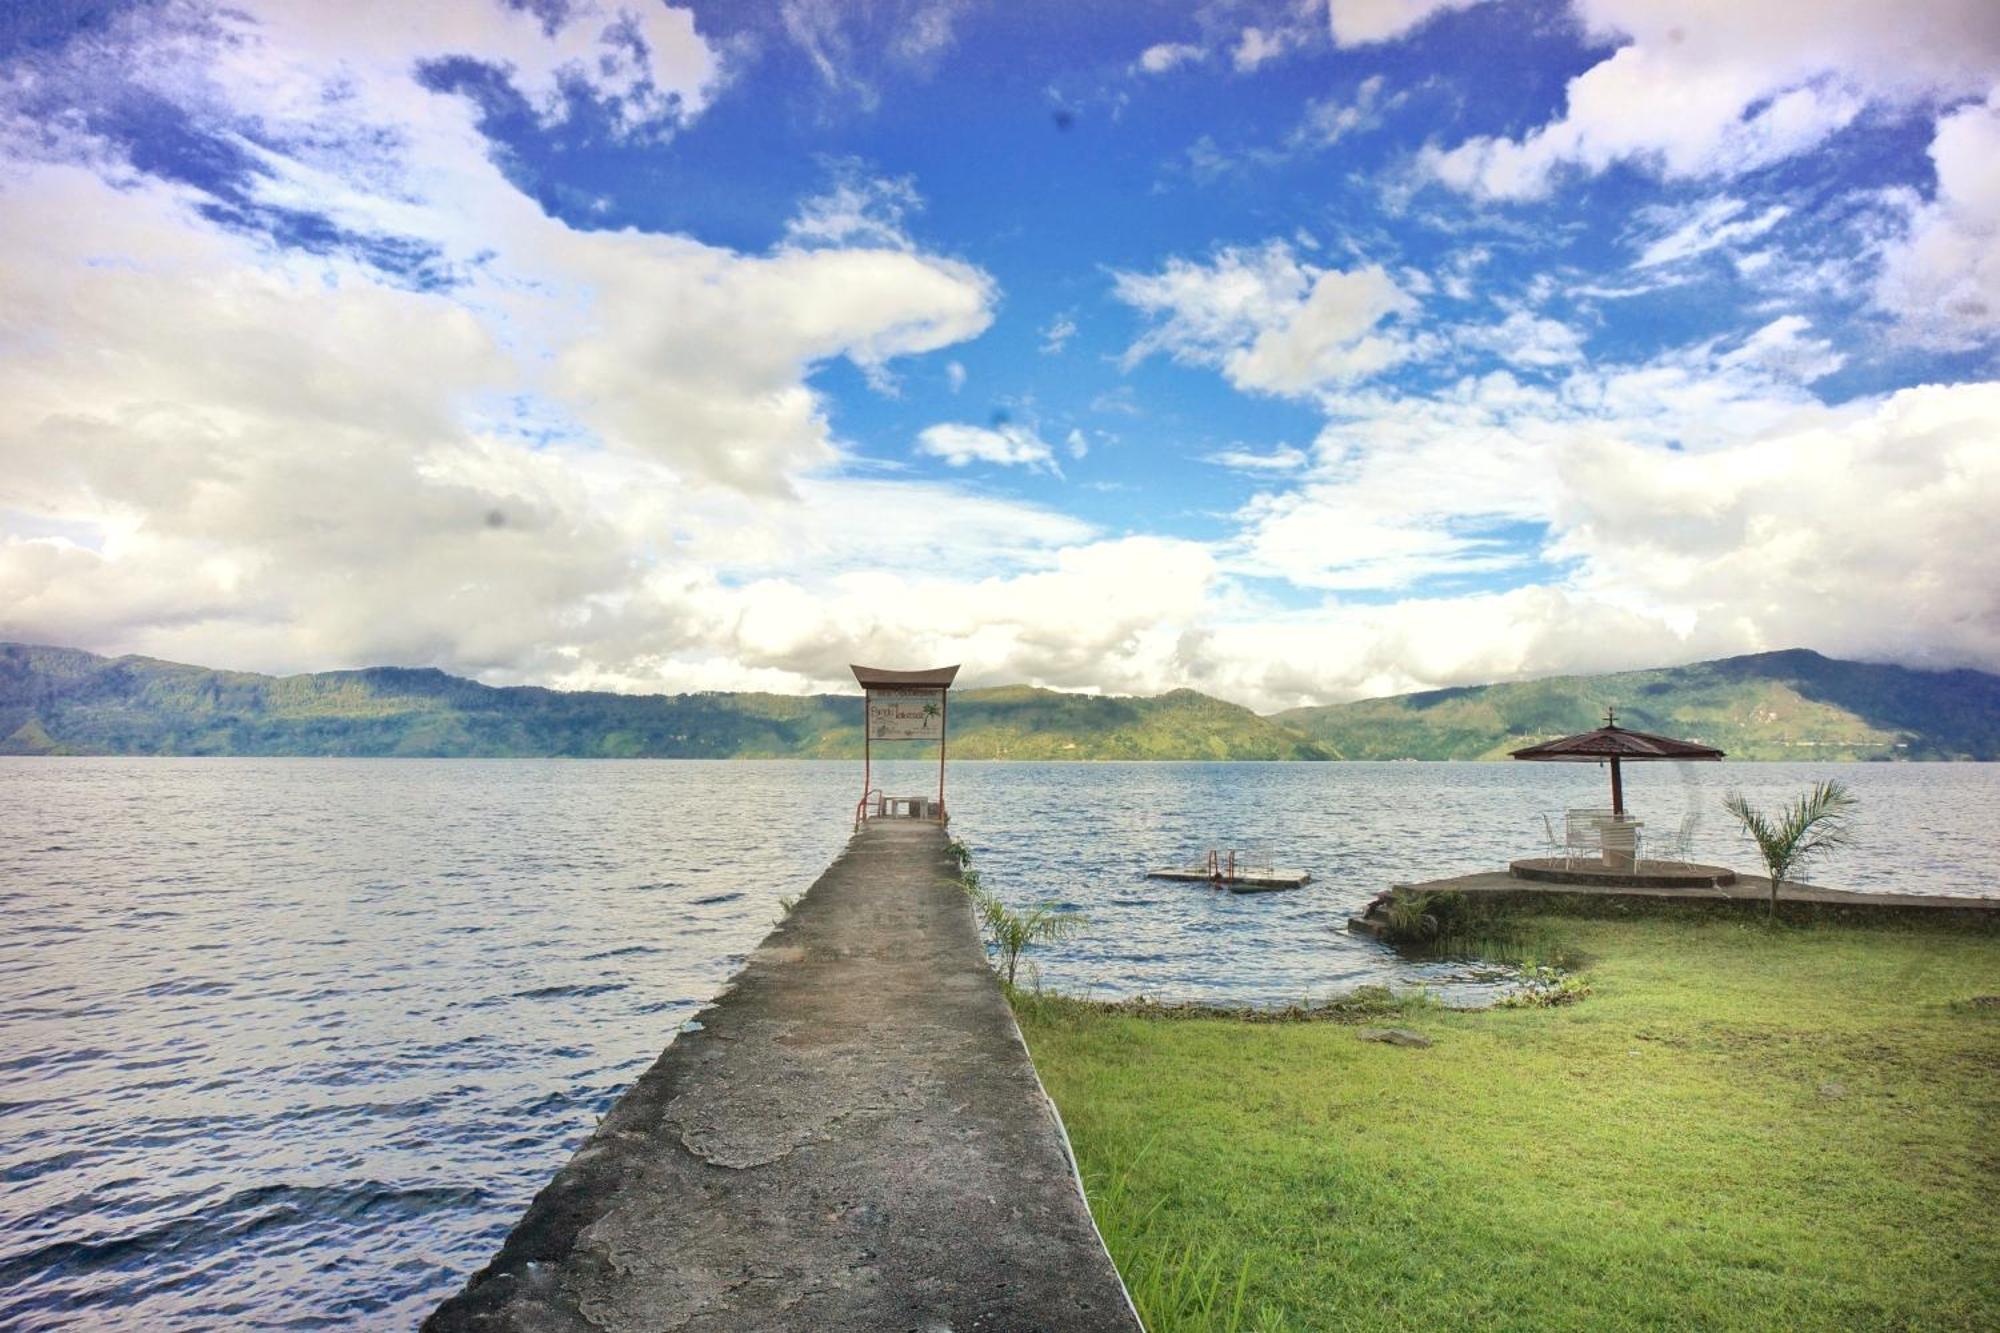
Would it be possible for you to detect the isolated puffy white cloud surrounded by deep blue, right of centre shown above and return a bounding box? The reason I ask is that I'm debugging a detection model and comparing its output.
[1114,240,1416,394]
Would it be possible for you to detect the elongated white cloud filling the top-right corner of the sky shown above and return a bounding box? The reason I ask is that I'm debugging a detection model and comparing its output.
[1418,0,2000,198]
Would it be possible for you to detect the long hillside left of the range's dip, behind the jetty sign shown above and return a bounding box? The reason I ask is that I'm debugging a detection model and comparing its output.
[0,644,1334,759]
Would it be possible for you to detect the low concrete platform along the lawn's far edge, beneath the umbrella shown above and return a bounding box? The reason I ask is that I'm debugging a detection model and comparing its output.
[1348,861,2000,935]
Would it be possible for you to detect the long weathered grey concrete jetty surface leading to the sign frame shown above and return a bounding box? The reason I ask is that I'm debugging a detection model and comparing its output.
[424,821,1140,1333]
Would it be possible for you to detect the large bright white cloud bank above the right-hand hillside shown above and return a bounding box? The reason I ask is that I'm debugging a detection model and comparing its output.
[1554,384,2000,662]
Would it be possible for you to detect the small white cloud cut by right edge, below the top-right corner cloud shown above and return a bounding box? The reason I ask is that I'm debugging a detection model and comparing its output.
[1876,88,2000,348]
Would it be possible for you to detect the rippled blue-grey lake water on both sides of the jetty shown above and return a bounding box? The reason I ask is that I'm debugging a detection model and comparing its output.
[0,759,2000,1329]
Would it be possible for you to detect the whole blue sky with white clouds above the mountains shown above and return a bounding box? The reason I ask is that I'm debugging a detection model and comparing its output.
[0,0,2000,709]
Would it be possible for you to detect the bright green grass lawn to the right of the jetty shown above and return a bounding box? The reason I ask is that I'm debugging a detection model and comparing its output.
[1018,917,2000,1333]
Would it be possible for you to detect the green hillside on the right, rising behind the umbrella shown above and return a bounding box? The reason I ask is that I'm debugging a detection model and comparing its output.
[1272,648,2000,759]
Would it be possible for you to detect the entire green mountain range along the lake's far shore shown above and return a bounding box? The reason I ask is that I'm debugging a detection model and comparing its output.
[0,642,2000,761]
